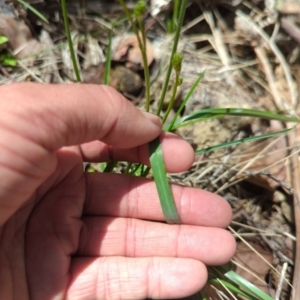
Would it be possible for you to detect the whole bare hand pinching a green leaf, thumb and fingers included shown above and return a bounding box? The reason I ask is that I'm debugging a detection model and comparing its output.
[0,83,235,300]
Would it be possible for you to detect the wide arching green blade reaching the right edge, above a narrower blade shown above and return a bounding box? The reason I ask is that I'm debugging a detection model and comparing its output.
[170,108,300,129]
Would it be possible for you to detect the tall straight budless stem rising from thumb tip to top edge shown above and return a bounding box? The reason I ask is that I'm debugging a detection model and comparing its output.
[156,0,187,116]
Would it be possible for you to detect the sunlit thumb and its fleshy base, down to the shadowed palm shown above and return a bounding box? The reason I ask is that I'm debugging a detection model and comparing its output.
[0,84,162,224]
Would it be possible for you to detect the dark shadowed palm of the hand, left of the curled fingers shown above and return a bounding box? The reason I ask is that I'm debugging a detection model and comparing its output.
[1,150,86,300]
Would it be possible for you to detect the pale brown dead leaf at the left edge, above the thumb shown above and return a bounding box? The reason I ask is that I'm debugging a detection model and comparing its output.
[0,15,43,58]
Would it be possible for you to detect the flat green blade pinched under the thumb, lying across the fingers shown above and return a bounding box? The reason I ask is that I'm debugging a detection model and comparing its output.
[149,138,181,224]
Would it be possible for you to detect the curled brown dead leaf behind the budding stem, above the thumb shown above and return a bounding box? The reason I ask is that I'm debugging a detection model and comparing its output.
[112,34,154,70]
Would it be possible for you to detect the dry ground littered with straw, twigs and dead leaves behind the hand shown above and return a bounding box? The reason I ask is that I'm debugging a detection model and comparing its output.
[0,0,300,299]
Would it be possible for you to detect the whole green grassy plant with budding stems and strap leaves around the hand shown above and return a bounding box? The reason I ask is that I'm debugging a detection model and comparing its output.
[59,0,300,300]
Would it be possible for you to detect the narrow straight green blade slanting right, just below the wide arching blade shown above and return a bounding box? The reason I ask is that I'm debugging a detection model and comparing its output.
[195,127,293,155]
